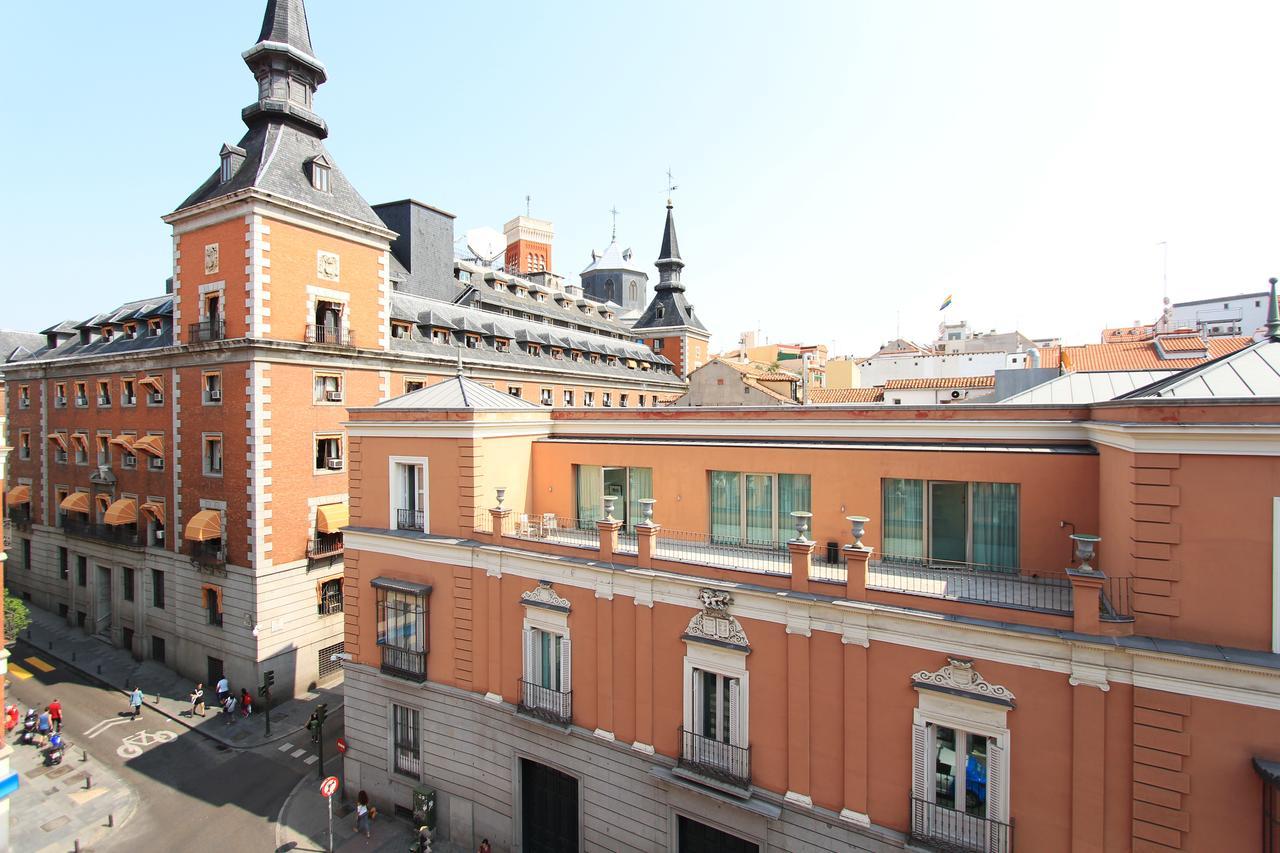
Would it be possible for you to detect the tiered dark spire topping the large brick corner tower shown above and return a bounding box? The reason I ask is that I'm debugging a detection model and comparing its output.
[241,0,329,138]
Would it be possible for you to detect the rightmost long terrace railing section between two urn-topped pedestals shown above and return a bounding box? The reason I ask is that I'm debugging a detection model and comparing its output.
[867,555,1071,615]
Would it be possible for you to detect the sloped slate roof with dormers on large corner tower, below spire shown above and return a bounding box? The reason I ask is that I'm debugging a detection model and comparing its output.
[178,122,387,229]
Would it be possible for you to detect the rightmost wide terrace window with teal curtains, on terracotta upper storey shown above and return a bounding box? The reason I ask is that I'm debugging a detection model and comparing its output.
[881,478,1020,571]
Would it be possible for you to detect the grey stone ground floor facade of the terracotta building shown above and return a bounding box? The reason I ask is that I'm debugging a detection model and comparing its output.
[343,663,905,853]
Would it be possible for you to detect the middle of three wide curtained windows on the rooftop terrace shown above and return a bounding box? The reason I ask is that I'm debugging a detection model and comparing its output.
[709,471,810,544]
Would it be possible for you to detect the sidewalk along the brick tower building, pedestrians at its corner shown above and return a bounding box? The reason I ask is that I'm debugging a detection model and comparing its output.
[22,607,342,749]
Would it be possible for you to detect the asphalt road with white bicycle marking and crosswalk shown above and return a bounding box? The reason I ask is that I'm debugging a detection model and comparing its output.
[5,642,340,853]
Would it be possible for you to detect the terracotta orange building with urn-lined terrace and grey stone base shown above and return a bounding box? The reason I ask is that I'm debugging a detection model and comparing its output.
[344,321,1280,853]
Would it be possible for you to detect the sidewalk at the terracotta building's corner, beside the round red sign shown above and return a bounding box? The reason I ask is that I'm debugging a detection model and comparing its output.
[275,776,465,853]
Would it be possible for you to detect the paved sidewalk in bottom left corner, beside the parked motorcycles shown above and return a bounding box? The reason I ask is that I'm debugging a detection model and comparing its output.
[9,743,138,853]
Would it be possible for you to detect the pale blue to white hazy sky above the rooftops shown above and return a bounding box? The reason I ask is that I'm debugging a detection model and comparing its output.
[0,0,1280,355]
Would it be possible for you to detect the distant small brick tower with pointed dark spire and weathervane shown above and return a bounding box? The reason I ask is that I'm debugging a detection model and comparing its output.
[631,200,712,377]
